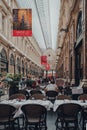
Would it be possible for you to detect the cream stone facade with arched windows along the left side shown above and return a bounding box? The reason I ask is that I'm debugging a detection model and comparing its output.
[0,0,42,76]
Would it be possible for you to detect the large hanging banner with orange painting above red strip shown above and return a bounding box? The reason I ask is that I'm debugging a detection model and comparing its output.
[13,9,32,36]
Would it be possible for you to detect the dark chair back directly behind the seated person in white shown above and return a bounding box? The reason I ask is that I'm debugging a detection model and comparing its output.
[46,90,58,102]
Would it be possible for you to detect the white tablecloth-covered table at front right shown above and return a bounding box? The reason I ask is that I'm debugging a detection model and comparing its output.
[53,99,87,112]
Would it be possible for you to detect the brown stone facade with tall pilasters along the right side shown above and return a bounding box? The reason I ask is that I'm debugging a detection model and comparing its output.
[56,0,87,86]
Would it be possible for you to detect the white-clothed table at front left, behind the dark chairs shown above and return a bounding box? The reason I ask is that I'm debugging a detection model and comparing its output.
[1,99,53,118]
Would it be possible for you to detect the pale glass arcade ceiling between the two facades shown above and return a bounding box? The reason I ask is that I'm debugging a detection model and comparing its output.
[17,0,60,50]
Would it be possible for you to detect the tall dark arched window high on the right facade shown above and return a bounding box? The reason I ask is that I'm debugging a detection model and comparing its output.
[76,11,82,39]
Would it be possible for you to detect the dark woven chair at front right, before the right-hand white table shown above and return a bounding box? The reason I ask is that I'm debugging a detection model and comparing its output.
[55,103,83,130]
